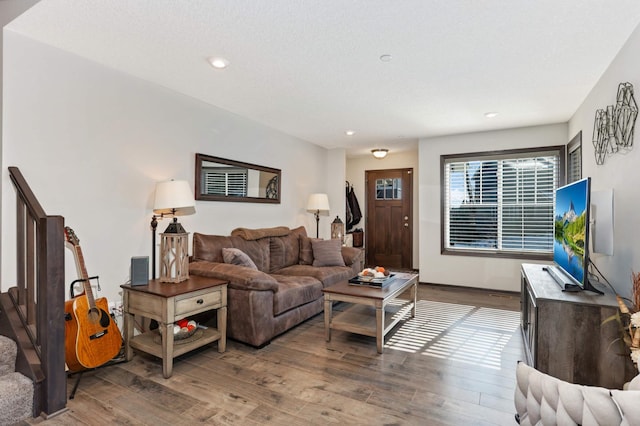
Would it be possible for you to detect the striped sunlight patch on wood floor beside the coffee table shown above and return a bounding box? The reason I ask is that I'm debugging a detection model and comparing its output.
[385,300,520,369]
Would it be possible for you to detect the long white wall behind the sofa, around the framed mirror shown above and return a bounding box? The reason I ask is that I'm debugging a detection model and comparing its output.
[1,31,336,300]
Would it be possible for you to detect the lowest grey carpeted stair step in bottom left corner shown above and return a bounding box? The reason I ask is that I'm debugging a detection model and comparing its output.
[0,372,33,425]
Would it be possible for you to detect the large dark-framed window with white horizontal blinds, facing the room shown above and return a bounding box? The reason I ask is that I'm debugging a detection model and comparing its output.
[442,147,564,257]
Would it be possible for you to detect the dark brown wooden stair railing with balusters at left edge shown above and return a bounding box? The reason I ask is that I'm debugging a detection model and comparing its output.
[3,167,67,417]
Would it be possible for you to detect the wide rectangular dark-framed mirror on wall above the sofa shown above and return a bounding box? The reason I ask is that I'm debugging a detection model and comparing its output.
[195,154,281,203]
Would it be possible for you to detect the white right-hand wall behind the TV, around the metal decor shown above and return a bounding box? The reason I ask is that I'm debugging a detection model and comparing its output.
[569,21,640,296]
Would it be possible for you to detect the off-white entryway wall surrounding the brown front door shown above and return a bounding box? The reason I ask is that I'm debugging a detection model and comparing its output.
[343,150,422,266]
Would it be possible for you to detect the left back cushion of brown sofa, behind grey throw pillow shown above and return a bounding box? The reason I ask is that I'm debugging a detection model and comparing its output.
[193,232,269,272]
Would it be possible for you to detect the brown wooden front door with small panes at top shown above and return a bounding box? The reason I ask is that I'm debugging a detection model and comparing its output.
[365,169,413,269]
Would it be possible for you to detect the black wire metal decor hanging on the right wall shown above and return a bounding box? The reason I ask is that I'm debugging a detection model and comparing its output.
[593,83,638,165]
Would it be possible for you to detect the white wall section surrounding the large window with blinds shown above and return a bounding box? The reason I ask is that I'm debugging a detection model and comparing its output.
[418,124,568,291]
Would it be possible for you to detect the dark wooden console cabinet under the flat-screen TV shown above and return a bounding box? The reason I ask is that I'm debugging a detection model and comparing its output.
[520,264,637,389]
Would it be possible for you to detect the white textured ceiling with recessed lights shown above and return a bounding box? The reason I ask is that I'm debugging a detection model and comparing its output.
[7,0,640,156]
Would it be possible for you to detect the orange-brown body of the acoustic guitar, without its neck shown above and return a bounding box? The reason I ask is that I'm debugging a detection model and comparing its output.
[67,296,122,371]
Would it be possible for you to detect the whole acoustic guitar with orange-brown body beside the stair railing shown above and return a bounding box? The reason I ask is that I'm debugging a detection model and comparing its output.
[64,226,122,371]
